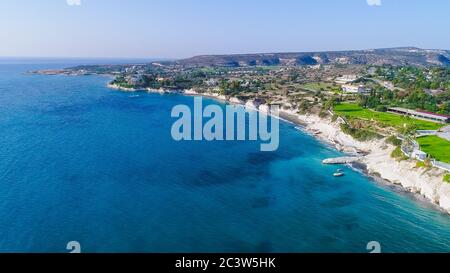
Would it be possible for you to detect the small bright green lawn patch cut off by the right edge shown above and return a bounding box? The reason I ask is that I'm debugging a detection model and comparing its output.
[417,136,450,163]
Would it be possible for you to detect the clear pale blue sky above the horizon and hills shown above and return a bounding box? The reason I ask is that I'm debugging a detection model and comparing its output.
[0,0,450,58]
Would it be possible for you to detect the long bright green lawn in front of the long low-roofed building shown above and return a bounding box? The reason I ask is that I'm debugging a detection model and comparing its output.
[334,103,444,130]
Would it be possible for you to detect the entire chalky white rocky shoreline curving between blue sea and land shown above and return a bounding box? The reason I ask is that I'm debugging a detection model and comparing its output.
[108,84,450,214]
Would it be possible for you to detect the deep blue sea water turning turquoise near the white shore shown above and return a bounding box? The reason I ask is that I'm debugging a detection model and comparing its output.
[0,62,450,252]
